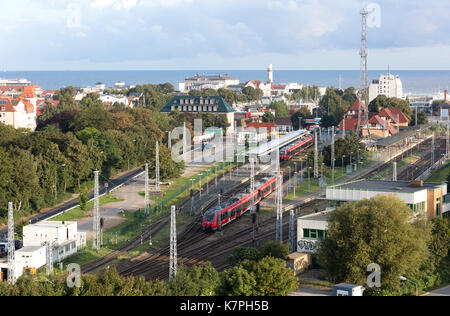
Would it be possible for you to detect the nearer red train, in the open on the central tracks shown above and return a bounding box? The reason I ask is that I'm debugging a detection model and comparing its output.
[202,176,277,232]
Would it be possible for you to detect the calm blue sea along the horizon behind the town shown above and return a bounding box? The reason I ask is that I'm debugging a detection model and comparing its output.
[0,70,450,95]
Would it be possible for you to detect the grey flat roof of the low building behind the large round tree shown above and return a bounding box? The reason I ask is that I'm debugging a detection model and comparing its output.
[329,180,445,193]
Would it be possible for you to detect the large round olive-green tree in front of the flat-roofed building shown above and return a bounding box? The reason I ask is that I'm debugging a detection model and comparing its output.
[317,196,430,294]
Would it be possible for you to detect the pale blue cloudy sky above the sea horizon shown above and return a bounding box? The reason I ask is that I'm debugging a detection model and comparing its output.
[0,0,450,70]
